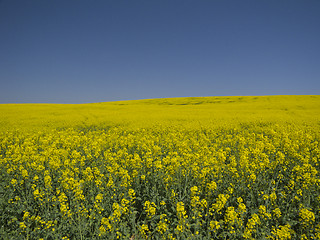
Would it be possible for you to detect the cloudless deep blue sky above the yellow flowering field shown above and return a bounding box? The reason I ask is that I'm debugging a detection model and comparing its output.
[0,0,320,103]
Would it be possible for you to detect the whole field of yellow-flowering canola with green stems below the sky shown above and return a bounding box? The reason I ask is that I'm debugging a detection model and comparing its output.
[0,96,320,240]
